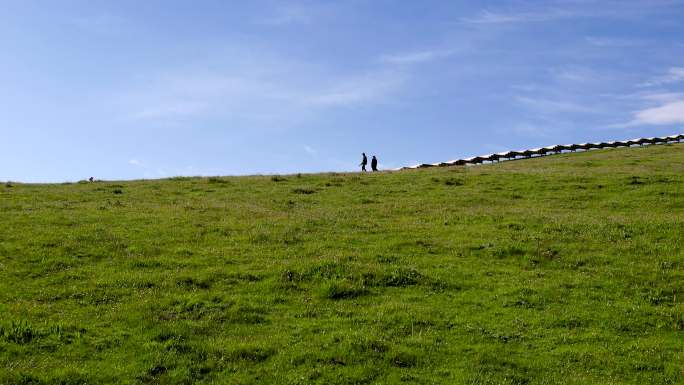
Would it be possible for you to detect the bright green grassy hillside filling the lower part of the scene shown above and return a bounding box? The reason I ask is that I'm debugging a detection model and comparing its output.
[0,145,684,384]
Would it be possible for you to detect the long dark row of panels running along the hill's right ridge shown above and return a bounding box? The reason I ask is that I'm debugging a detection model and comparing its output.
[403,134,684,169]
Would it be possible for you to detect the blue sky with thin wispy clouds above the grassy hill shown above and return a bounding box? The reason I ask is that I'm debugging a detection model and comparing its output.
[0,0,684,182]
